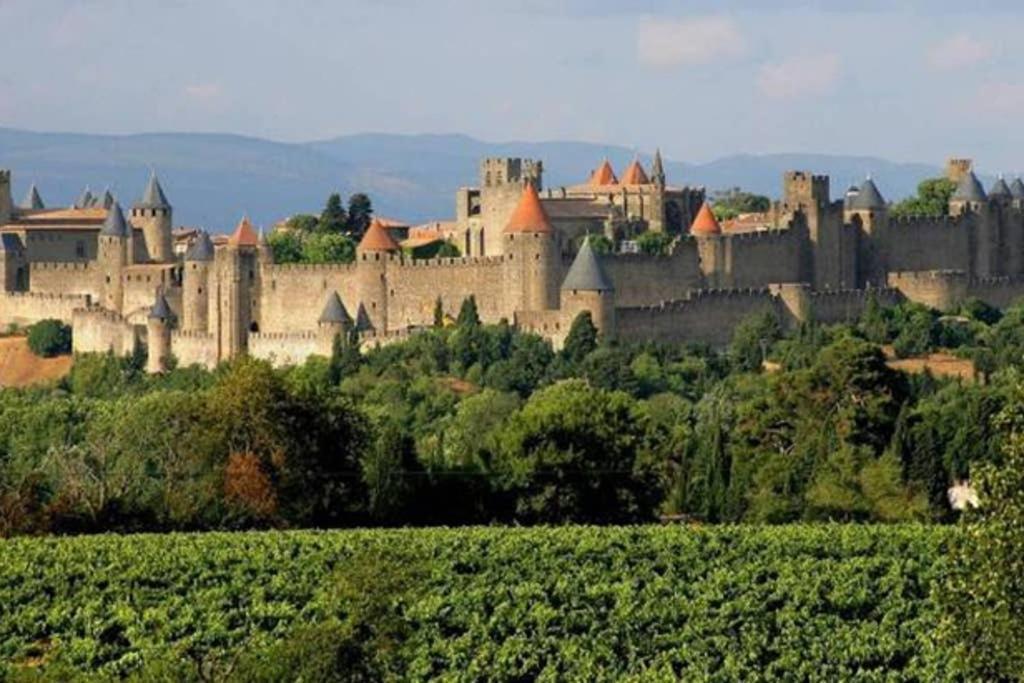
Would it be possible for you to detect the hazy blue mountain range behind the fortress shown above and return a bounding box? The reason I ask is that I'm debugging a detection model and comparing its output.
[0,128,939,232]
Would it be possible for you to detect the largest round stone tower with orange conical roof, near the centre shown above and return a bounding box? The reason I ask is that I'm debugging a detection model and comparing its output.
[503,183,558,313]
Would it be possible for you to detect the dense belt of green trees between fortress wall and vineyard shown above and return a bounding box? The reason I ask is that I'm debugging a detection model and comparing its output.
[0,299,1024,533]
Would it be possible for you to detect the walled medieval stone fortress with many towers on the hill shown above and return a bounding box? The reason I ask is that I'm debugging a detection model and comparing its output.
[0,155,1024,372]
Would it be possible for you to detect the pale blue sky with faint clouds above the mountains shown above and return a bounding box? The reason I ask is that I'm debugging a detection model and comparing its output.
[0,0,1024,174]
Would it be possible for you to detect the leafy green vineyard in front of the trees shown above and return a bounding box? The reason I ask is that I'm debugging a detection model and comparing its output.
[0,525,951,681]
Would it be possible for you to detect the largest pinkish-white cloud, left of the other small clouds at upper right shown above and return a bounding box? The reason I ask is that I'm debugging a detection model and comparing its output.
[637,16,745,67]
